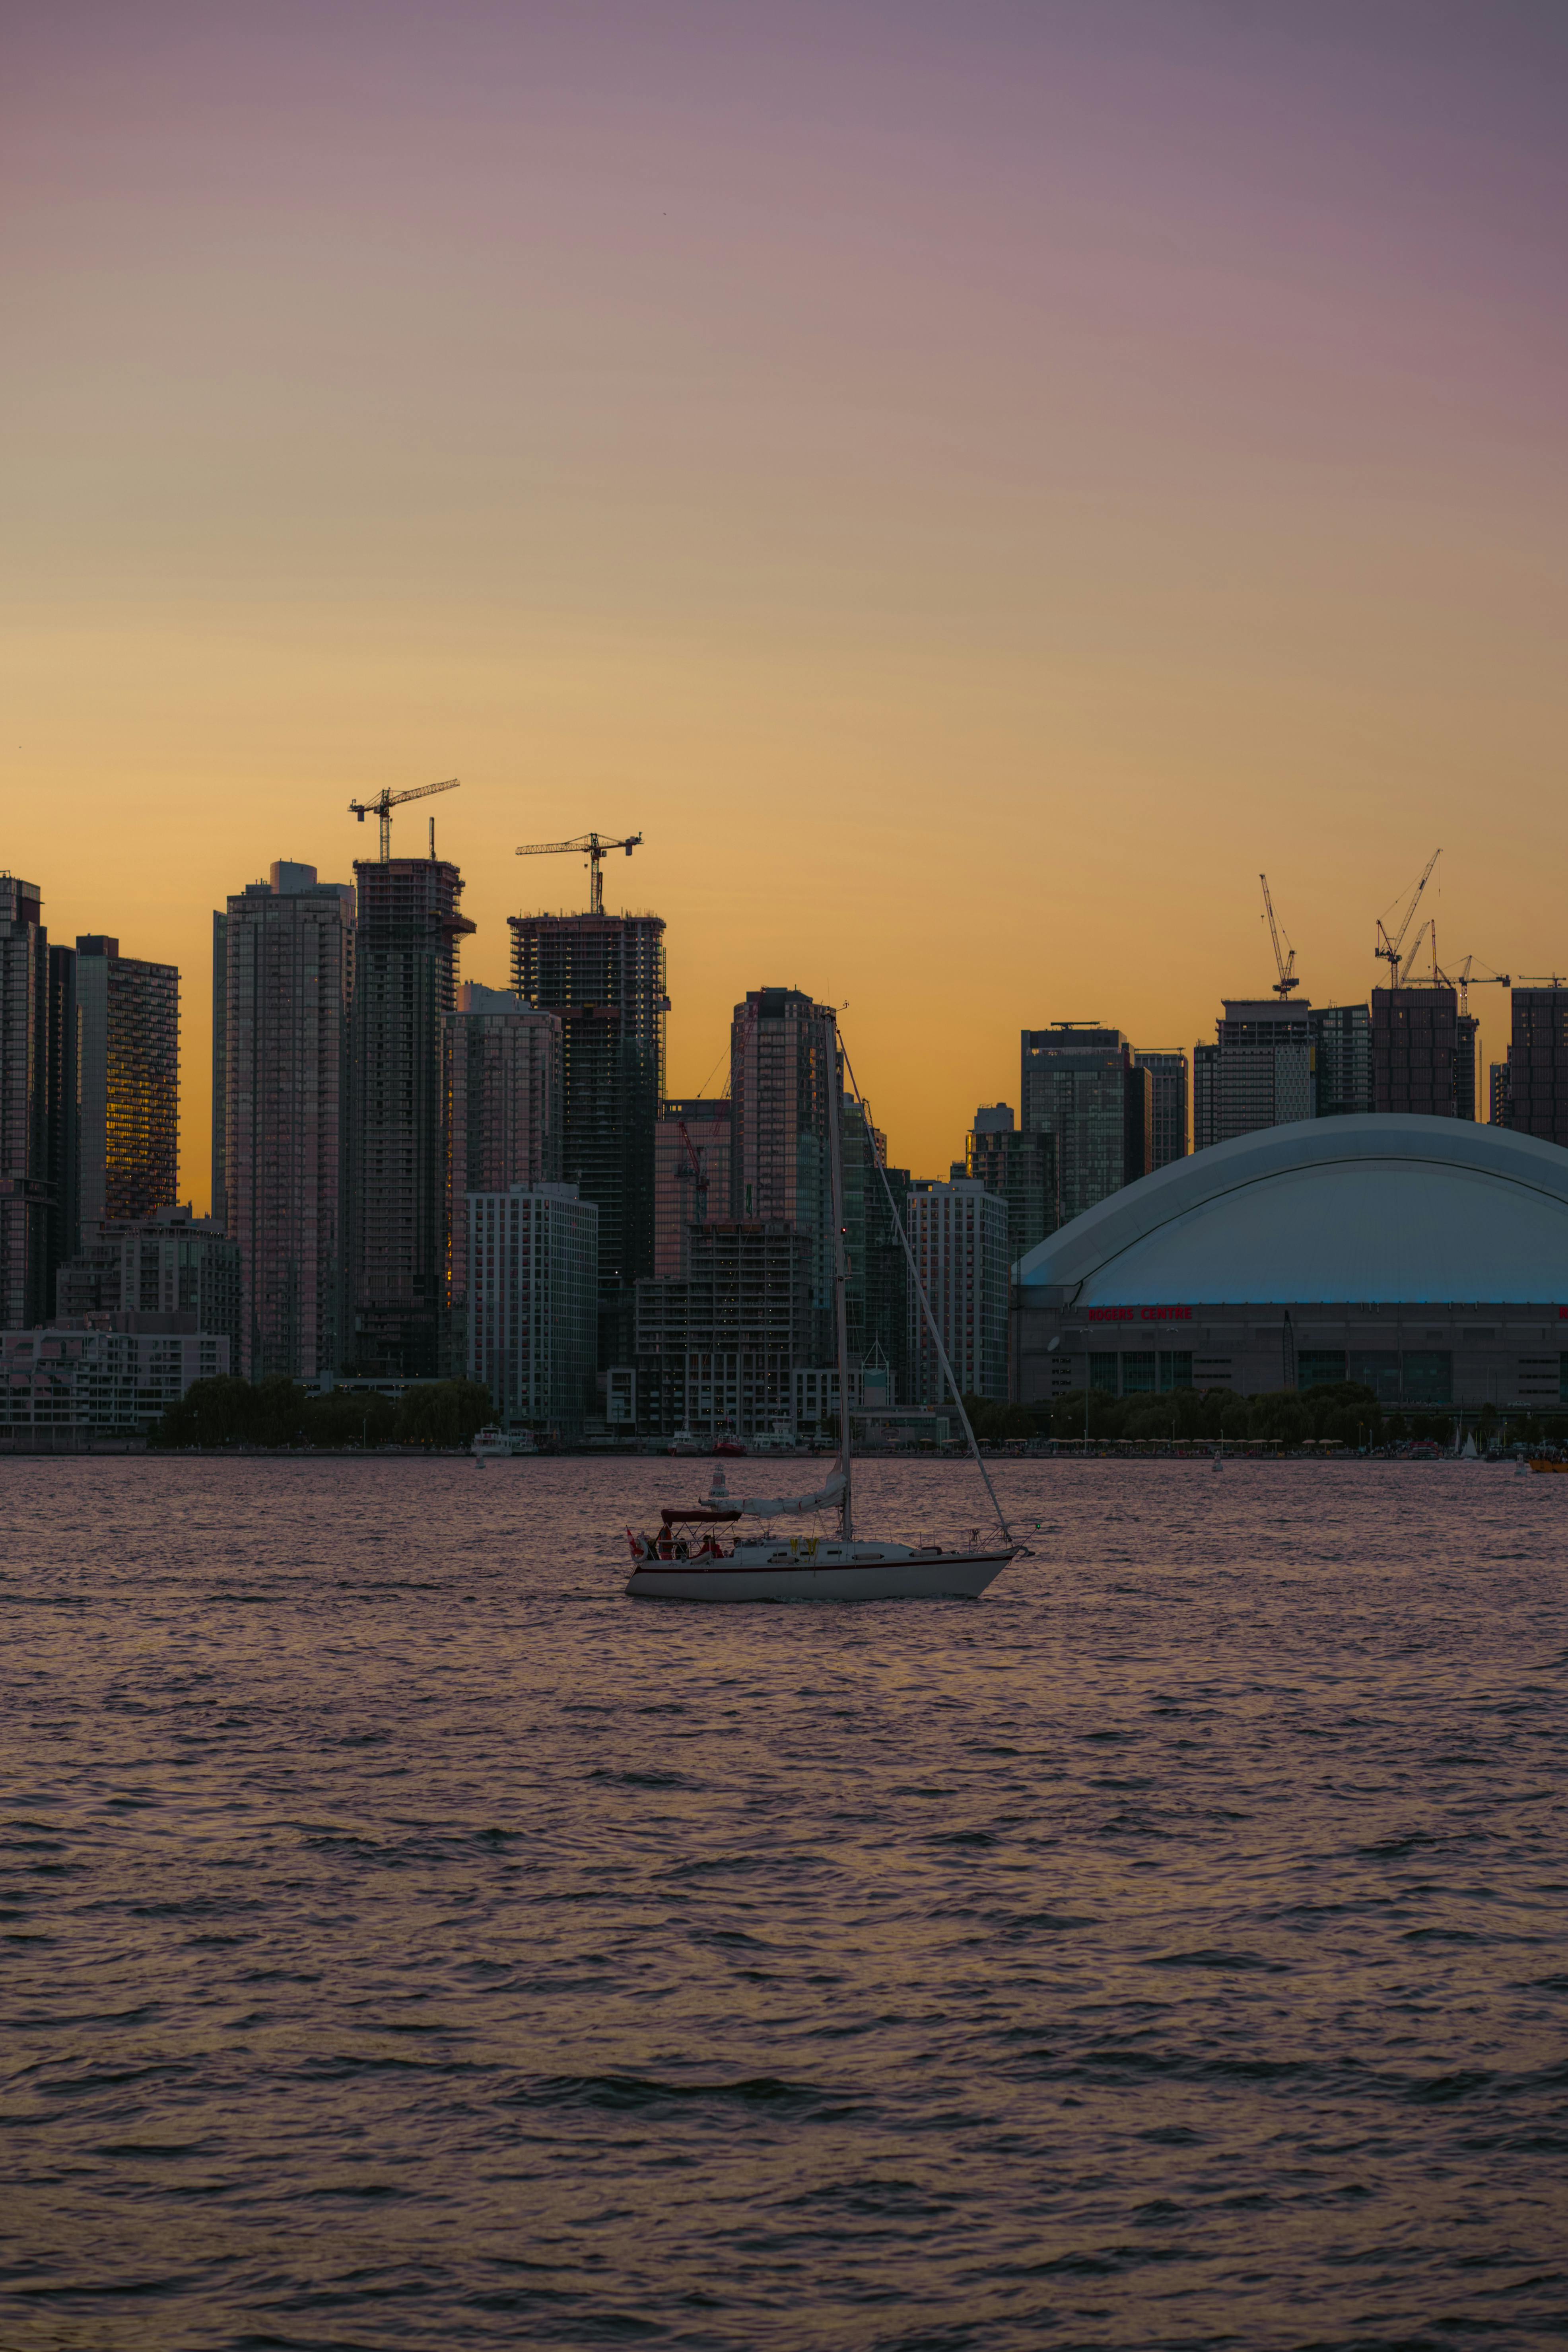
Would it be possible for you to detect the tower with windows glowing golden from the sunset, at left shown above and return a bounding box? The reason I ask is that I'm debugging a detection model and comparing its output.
[75,931,179,1226]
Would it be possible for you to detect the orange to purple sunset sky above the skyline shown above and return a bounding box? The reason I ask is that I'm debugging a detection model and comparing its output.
[0,0,1568,1204]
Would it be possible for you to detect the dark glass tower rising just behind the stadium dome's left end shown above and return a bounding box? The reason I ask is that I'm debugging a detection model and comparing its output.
[1018,1021,1154,1223]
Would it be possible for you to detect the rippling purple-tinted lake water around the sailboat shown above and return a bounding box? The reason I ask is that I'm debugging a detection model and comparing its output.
[0,1458,1568,2352]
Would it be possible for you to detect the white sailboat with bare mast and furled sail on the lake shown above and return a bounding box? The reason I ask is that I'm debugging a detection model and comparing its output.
[625,1025,1023,1602]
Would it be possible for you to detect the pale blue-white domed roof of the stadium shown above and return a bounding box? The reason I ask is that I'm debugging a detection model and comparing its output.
[1013,1115,1568,1308]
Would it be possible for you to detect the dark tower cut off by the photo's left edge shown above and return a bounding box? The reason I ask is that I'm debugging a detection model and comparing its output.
[0,872,56,1329]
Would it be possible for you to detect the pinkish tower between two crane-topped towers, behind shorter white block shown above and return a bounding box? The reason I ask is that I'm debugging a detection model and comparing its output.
[447,981,564,1378]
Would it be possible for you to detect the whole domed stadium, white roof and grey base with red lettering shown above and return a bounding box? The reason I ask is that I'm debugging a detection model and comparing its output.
[1011,1115,1568,1411]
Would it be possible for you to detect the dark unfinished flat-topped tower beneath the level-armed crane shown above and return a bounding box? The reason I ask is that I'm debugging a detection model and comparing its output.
[508,915,670,1362]
